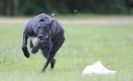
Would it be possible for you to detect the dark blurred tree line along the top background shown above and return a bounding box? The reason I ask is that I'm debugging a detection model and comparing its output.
[0,0,133,16]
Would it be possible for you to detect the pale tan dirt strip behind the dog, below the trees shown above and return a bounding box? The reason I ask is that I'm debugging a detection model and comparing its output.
[0,17,133,24]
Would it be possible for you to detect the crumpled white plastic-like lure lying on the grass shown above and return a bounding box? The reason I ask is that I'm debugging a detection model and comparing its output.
[82,61,117,76]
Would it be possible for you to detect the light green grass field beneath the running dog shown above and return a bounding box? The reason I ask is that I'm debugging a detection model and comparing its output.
[0,16,133,81]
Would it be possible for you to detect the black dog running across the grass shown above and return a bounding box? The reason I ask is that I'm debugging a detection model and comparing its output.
[22,13,65,71]
